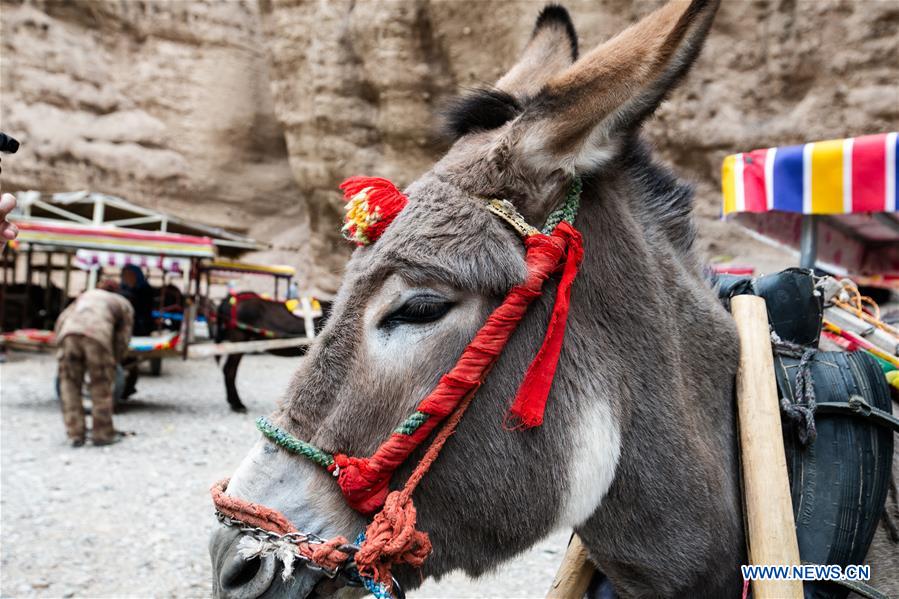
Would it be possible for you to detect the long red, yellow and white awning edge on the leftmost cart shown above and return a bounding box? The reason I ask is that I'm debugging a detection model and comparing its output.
[11,219,215,258]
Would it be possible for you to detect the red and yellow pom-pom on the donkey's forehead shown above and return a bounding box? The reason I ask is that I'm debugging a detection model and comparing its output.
[340,177,409,245]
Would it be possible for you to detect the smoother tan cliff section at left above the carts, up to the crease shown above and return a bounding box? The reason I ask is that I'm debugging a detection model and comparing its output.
[0,0,308,284]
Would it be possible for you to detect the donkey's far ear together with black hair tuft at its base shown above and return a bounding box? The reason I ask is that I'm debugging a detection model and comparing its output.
[440,4,577,141]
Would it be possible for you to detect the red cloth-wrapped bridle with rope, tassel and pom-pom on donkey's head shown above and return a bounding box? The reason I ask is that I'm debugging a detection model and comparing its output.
[213,177,583,584]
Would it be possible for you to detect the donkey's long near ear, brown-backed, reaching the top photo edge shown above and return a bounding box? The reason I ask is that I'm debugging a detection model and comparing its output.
[506,0,720,174]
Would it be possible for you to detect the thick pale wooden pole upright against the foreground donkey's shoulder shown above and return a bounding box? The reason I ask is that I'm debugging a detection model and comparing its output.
[731,295,803,599]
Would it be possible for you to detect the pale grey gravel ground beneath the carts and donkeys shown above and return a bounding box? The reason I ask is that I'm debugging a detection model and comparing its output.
[0,353,567,597]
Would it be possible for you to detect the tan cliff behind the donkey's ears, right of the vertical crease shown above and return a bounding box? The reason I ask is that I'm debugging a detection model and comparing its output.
[261,0,899,286]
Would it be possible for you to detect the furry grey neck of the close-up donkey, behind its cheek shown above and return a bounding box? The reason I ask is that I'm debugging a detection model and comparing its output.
[562,154,744,596]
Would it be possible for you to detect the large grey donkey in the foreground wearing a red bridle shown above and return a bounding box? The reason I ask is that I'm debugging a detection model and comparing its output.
[210,0,899,598]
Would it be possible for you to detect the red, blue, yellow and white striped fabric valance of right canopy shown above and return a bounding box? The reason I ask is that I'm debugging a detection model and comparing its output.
[721,132,899,215]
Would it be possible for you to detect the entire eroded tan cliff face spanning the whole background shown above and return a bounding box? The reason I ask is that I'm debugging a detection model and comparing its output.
[2,0,899,291]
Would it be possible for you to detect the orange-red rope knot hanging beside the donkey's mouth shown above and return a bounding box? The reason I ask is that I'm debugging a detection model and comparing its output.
[356,491,431,585]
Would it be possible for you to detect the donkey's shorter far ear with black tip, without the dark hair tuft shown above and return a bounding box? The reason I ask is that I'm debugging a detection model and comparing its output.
[496,4,578,100]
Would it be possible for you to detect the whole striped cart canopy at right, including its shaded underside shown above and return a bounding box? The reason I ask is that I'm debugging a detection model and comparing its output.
[721,132,899,274]
